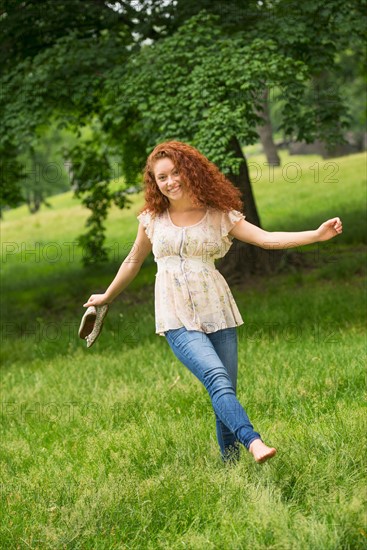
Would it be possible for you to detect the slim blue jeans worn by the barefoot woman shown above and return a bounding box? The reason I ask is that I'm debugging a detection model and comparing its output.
[165,327,261,461]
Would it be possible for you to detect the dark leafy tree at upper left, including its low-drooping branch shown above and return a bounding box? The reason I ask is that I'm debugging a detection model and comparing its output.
[0,0,134,262]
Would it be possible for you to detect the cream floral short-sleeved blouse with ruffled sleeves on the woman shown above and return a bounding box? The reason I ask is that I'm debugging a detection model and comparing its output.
[138,208,245,336]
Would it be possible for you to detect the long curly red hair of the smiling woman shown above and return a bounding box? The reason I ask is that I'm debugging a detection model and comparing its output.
[143,141,243,214]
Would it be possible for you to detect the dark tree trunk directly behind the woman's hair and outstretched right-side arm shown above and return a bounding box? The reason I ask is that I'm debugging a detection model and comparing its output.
[218,137,282,284]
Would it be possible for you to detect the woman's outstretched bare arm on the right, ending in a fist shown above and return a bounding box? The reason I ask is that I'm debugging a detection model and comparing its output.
[229,218,343,249]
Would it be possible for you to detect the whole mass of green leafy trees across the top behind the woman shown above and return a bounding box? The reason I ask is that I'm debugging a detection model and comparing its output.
[0,0,365,276]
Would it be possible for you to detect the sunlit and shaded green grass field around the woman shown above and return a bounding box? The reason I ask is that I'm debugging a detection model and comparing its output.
[0,154,367,550]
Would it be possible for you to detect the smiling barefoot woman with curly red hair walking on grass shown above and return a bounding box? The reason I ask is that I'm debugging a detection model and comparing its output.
[84,141,342,463]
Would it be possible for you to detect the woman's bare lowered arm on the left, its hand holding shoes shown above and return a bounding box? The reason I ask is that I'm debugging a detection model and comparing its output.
[83,223,152,307]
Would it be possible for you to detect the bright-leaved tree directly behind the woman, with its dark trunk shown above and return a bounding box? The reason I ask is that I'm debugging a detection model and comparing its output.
[101,13,350,282]
